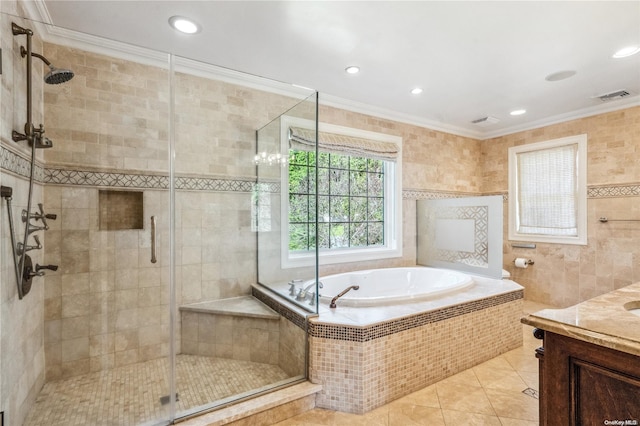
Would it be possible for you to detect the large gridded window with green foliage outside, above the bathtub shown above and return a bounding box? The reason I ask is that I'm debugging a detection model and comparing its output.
[282,117,402,267]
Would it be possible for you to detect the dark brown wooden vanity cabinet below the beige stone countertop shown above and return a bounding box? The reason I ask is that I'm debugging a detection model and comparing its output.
[534,329,640,426]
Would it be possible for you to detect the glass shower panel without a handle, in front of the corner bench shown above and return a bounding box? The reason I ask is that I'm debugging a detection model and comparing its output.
[173,58,316,417]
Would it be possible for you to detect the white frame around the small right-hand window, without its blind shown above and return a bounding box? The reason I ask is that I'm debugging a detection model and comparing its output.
[509,134,587,245]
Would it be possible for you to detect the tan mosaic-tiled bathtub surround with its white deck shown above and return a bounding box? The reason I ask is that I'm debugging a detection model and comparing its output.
[254,268,523,414]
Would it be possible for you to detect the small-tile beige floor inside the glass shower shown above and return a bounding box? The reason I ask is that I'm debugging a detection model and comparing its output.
[24,355,288,426]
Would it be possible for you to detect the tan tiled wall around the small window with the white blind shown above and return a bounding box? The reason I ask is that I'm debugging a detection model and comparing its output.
[481,107,640,306]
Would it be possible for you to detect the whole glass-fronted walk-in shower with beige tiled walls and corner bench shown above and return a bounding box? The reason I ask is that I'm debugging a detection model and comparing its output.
[0,10,317,425]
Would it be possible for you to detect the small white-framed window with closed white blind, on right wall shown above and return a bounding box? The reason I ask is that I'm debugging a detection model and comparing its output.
[509,135,587,245]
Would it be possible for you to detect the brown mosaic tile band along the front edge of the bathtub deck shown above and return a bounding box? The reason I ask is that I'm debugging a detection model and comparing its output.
[309,290,524,343]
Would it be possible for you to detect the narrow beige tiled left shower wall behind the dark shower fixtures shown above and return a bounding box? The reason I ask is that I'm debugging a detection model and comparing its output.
[0,7,50,424]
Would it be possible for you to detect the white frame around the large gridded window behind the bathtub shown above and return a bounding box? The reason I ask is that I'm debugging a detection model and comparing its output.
[280,116,402,269]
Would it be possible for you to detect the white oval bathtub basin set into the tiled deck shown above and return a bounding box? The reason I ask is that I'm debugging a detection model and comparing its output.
[320,266,474,306]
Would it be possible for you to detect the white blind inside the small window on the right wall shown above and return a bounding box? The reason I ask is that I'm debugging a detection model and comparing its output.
[517,144,578,236]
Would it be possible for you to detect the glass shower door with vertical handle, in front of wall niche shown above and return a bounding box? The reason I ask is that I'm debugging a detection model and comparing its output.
[0,15,172,426]
